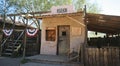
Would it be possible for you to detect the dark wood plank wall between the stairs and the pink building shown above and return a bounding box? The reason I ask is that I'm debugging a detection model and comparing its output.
[26,31,41,56]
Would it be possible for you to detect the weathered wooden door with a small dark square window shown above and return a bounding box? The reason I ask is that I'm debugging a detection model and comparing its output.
[58,26,70,56]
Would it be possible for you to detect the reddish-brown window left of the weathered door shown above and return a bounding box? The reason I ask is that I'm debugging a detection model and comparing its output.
[46,30,56,41]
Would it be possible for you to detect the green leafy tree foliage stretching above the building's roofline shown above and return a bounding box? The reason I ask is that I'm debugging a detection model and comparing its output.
[0,0,100,14]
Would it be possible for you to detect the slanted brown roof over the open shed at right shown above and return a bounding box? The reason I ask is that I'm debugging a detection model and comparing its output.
[87,13,120,34]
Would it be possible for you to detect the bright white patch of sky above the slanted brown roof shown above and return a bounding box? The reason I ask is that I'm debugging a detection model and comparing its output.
[91,0,120,16]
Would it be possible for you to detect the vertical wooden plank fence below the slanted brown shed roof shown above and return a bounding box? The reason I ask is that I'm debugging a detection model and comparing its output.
[84,47,120,66]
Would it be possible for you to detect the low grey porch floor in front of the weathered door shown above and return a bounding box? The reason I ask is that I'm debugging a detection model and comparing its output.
[26,55,84,66]
